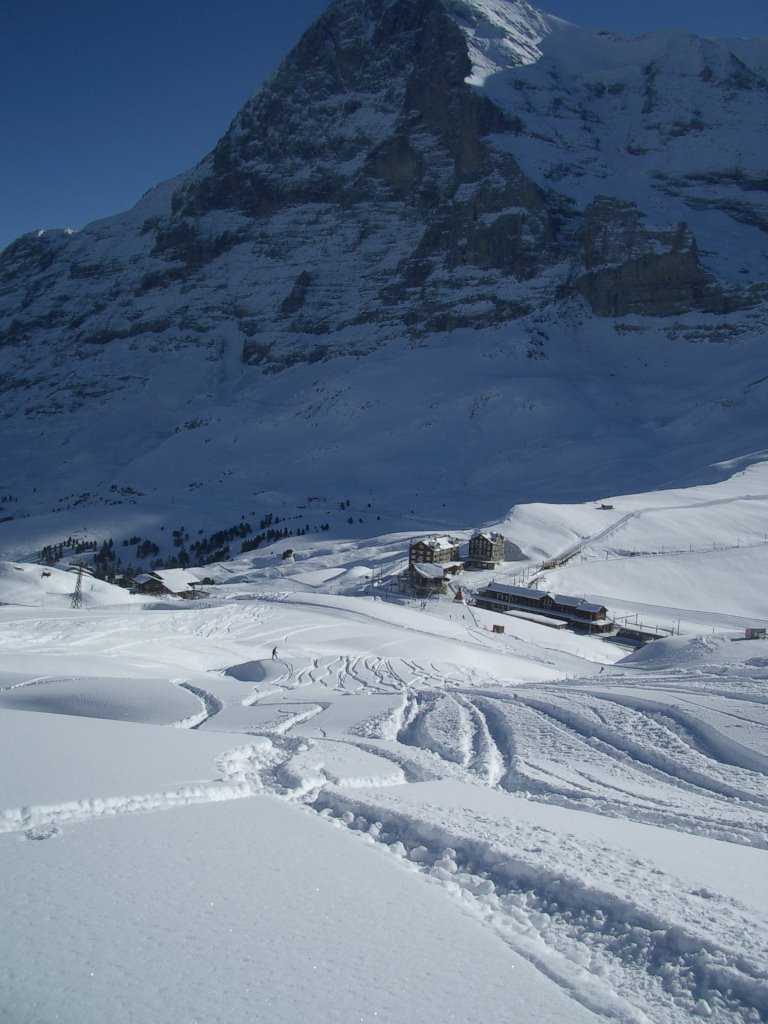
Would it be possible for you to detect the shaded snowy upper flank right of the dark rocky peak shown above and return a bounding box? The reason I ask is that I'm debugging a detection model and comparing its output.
[488,29,768,283]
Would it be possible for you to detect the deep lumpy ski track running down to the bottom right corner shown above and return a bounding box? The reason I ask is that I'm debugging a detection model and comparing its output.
[315,790,768,1024]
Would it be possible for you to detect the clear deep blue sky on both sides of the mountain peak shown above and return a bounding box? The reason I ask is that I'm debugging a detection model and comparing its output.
[0,0,768,248]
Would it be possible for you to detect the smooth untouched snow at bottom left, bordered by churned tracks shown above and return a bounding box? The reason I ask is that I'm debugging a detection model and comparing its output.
[0,797,606,1024]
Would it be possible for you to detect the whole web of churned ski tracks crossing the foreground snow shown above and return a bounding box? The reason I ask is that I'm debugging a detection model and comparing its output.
[6,620,768,1024]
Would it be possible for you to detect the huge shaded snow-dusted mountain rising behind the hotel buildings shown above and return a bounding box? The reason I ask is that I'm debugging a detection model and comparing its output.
[0,0,768,548]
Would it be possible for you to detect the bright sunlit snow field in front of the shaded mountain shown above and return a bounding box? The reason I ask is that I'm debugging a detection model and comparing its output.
[0,463,768,1024]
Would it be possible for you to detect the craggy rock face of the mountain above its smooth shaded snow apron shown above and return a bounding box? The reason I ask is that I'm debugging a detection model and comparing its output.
[0,0,768,524]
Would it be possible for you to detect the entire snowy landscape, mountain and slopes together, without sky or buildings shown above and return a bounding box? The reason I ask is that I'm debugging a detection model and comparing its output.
[0,0,768,1024]
